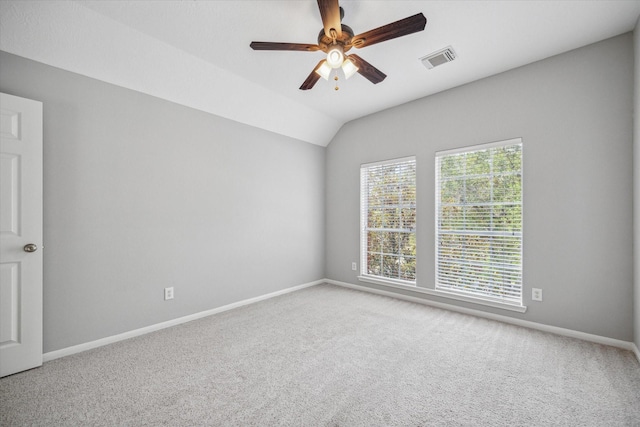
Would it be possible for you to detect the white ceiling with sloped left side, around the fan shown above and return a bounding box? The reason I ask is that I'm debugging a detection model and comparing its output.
[0,0,640,146]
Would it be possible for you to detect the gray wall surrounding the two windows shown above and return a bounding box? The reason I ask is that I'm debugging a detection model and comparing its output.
[326,33,633,341]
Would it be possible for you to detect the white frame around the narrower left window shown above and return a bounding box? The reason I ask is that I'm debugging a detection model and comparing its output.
[358,156,418,288]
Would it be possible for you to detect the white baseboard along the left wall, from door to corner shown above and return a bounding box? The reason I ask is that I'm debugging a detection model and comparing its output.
[42,280,326,362]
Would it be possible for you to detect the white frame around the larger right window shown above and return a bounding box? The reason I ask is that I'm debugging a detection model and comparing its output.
[429,138,526,312]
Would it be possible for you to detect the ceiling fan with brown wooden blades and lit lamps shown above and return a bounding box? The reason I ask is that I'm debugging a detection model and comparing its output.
[250,0,427,90]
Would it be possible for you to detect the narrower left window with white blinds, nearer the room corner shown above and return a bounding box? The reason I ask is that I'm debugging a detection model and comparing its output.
[360,157,416,285]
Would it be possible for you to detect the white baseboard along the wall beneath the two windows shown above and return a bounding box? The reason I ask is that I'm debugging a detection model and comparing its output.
[325,279,640,356]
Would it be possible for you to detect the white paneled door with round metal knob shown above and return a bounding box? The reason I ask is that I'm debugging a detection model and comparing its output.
[0,93,42,376]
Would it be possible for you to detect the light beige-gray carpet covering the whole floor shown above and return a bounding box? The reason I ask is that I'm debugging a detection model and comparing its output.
[0,285,640,426]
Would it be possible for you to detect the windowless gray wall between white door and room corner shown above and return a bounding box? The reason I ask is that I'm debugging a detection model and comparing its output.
[0,52,325,352]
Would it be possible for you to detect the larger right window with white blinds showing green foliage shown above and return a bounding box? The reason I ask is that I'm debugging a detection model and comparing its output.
[436,139,522,305]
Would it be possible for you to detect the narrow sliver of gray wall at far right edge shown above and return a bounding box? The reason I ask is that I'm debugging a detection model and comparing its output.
[633,18,640,349]
